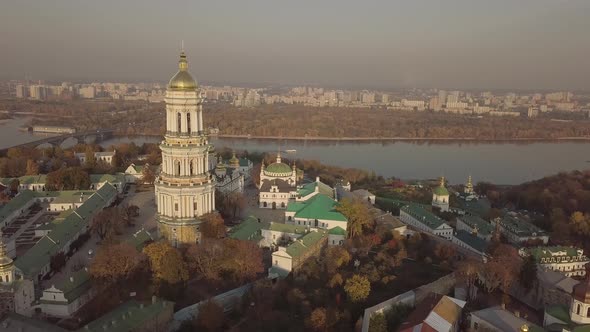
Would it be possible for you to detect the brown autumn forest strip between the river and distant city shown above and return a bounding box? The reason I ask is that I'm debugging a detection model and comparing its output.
[0,100,590,140]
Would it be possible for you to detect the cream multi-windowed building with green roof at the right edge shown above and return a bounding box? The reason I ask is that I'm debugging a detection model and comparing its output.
[518,246,590,277]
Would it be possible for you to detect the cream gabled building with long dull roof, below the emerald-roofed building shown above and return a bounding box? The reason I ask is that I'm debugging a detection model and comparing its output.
[268,230,328,278]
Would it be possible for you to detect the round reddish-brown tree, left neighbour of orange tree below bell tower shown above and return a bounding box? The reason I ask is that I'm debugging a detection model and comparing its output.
[90,243,145,286]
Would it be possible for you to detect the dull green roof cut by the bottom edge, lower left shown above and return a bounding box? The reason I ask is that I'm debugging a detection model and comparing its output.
[80,300,174,332]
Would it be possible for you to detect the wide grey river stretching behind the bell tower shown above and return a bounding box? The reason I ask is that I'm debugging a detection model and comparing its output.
[0,119,590,184]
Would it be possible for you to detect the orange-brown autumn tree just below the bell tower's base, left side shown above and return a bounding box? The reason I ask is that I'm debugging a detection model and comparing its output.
[143,241,188,285]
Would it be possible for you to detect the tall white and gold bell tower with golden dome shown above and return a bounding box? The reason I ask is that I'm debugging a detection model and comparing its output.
[155,52,215,246]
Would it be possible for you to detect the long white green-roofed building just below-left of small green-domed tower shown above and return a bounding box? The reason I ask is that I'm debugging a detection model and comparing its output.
[400,204,453,240]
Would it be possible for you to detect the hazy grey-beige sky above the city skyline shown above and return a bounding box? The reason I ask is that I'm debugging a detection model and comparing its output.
[0,0,590,90]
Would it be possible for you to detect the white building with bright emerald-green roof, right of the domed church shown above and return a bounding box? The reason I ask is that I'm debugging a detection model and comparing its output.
[285,193,348,230]
